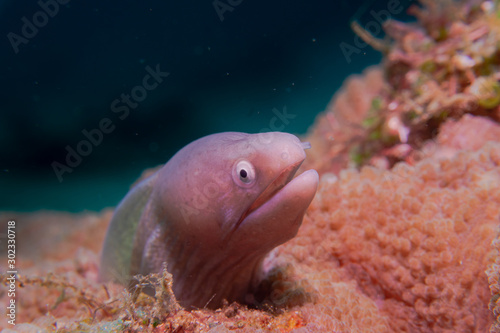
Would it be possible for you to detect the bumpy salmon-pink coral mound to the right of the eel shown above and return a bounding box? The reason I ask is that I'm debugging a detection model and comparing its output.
[292,144,500,332]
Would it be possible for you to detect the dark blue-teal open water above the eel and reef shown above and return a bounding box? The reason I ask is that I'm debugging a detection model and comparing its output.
[0,0,413,212]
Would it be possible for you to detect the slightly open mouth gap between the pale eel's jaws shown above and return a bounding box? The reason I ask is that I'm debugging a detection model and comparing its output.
[234,157,305,230]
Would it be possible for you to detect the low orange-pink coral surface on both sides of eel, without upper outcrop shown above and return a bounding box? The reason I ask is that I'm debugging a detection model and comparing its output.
[0,143,500,332]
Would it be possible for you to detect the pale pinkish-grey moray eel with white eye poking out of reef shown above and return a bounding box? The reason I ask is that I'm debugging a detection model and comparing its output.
[99,132,318,308]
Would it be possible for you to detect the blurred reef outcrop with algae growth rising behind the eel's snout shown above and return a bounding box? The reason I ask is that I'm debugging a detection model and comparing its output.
[305,1,500,173]
